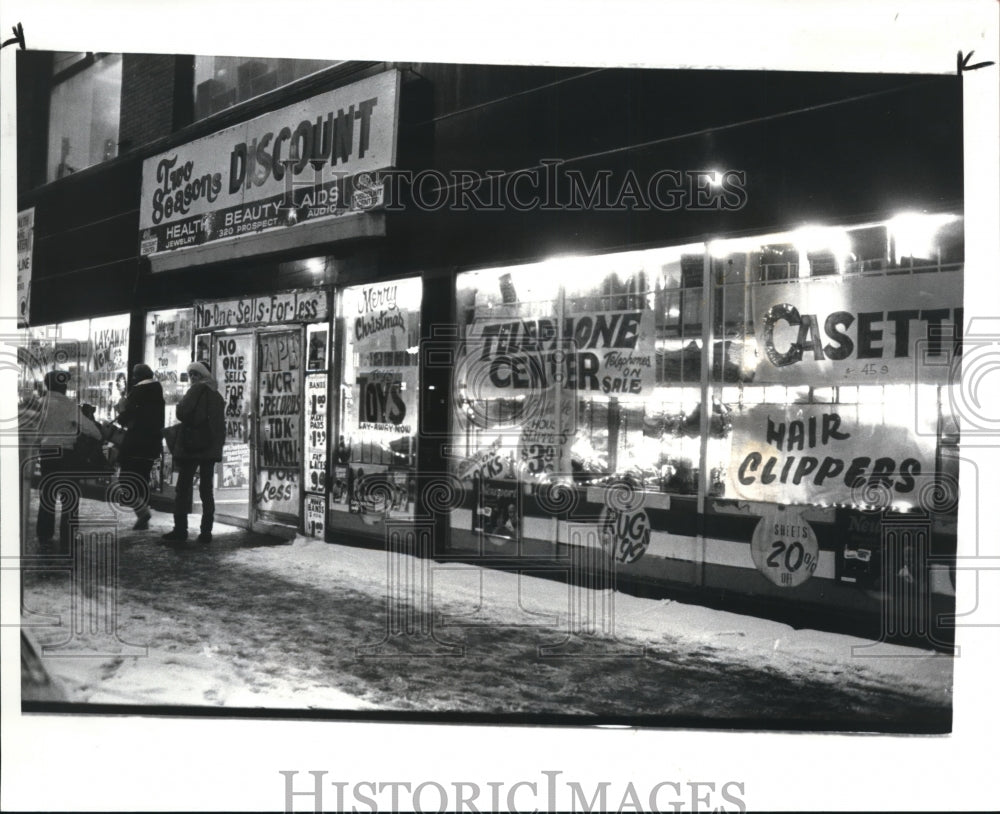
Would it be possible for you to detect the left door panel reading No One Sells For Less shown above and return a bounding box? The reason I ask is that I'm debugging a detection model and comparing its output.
[210,332,255,525]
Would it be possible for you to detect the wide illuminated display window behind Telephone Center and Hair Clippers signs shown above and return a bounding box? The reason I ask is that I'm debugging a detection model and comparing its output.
[453,216,962,522]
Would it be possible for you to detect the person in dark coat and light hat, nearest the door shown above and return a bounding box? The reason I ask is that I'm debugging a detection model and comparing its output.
[163,362,226,543]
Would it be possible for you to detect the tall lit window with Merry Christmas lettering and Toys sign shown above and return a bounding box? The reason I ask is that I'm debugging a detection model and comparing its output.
[330,278,423,525]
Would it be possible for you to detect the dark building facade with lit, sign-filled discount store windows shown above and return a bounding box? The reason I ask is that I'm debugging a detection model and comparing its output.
[18,52,964,642]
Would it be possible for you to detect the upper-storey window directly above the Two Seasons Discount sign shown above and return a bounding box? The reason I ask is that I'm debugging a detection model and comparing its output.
[194,56,337,119]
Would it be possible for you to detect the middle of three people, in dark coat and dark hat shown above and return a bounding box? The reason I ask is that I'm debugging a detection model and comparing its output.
[115,363,166,529]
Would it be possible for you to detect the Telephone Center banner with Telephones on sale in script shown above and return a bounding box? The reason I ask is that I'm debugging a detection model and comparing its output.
[456,309,656,399]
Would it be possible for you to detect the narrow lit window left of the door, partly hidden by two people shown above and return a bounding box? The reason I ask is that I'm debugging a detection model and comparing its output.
[143,308,193,492]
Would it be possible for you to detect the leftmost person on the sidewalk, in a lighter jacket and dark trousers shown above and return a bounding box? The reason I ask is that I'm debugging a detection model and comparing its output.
[28,370,101,550]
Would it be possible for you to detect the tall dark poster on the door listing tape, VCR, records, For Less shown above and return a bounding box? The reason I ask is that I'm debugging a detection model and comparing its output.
[254,331,302,521]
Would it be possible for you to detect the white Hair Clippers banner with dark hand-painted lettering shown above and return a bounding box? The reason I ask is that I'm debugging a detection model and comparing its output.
[726,404,935,504]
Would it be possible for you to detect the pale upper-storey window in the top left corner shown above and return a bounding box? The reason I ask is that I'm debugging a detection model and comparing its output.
[46,54,122,181]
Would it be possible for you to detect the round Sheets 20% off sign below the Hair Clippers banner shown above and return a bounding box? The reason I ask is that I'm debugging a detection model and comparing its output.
[750,506,819,588]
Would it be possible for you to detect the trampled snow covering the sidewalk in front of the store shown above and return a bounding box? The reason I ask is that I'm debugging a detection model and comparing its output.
[22,501,952,730]
